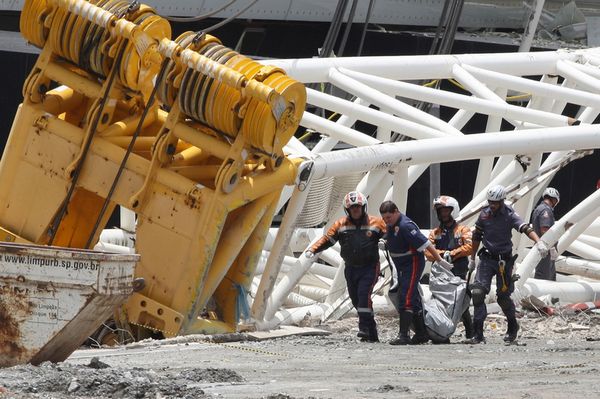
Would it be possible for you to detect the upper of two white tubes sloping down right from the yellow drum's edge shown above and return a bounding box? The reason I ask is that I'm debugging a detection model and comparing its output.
[306,88,446,141]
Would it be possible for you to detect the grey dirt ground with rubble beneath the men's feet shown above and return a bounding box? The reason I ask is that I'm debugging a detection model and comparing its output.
[0,312,600,399]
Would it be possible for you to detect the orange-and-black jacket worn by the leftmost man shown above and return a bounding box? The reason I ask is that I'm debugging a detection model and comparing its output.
[310,215,385,267]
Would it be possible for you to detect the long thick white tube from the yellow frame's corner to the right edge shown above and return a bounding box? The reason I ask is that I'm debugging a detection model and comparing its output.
[312,125,600,179]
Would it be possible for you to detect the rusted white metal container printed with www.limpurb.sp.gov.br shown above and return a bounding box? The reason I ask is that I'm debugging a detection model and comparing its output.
[0,243,139,367]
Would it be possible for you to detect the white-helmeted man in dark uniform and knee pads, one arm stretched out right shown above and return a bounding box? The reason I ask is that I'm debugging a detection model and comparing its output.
[469,185,548,344]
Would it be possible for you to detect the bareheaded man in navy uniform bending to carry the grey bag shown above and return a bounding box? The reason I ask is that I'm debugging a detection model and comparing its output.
[379,201,452,345]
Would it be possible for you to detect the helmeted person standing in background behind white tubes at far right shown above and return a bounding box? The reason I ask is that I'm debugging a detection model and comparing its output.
[531,187,560,281]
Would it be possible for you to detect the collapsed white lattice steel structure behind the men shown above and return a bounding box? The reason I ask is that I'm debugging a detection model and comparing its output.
[238,49,600,328]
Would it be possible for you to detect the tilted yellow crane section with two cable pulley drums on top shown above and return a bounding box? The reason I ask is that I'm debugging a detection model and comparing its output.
[0,0,306,338]
